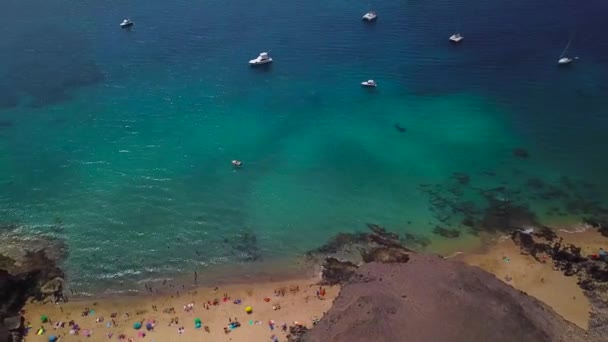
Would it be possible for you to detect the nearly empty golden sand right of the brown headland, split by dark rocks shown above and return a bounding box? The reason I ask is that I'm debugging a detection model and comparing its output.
[461,230,608,329]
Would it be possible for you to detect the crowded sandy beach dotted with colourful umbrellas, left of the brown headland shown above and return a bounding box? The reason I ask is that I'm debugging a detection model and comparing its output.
[24,278,339,342]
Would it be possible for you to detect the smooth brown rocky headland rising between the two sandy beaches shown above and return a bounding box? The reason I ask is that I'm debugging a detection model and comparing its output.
[302,254,590,342]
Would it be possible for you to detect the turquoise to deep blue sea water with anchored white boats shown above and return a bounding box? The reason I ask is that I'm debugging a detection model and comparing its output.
[0,0,608,289]
